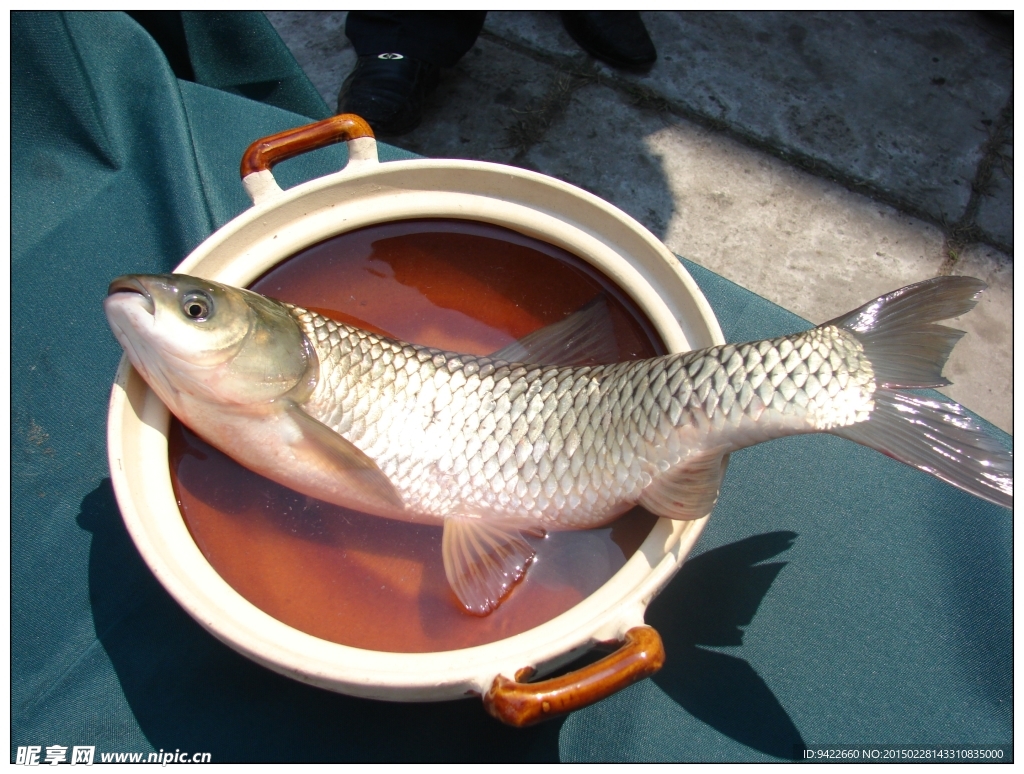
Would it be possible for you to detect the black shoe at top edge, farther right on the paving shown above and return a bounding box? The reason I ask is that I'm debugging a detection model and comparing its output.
[562,11,657,73]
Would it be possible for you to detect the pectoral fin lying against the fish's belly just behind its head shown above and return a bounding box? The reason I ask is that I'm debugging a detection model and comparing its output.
[286,400,404,511]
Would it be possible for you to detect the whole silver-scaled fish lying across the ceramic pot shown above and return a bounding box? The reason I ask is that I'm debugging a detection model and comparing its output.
[103,274,1013,615]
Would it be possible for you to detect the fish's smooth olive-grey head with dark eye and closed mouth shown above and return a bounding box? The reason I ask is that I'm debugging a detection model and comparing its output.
[103,274,317,417]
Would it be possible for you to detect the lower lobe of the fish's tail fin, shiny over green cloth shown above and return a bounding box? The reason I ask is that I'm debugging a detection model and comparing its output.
[829,390,1014,508]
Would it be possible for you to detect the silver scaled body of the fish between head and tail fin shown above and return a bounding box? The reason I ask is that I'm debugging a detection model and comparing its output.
[291,307,873,528]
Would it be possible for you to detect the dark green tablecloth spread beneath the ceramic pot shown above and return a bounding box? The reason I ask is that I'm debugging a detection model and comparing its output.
[10,13,1013,762]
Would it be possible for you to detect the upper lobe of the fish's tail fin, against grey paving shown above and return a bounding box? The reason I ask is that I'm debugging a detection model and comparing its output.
[821,276,987,389]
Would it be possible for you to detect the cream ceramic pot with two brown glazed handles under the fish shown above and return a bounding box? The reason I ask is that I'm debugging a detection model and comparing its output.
[108,116,724,725]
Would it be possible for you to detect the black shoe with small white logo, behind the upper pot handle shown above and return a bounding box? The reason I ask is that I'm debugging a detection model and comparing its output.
[338,53,440,136]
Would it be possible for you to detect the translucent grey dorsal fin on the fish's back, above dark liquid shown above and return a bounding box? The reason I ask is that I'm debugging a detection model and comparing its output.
[488,295,618,366]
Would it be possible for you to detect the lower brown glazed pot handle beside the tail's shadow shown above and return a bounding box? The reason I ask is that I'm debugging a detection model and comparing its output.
[483,627,665,727]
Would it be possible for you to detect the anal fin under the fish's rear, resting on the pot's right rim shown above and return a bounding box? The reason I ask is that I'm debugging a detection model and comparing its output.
[640,448,725,521]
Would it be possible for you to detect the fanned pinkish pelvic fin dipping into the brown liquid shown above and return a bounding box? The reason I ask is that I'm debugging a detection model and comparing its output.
[441,516,535,615]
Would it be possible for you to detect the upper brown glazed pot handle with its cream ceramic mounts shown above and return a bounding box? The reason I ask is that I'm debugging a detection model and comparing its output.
[239,113,377,204]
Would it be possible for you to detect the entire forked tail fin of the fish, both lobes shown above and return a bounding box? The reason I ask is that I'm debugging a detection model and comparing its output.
[825,276,1014,508]
